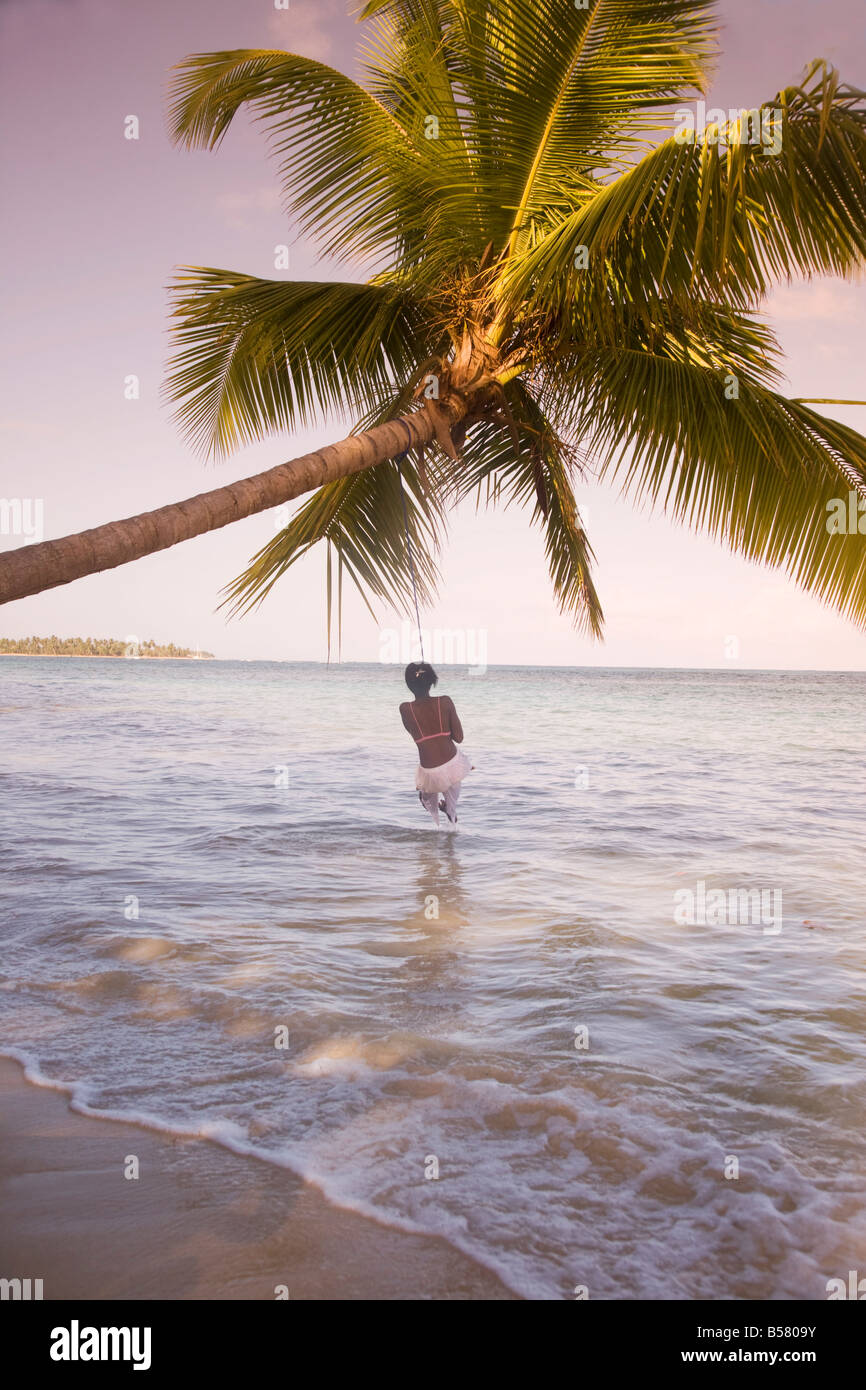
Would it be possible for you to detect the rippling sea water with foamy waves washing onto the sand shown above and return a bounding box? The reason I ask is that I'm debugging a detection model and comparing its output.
[0,659,866,1298]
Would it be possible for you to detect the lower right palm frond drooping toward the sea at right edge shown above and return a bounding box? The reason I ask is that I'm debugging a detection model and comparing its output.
[546,350,866,626]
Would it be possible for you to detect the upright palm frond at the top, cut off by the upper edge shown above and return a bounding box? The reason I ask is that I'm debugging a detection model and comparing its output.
[361,0,714,264]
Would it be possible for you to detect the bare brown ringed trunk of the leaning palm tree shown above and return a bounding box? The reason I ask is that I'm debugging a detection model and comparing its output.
[0,396,467,603]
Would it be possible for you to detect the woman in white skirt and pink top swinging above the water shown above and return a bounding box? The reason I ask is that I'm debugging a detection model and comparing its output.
[400,662,473,826]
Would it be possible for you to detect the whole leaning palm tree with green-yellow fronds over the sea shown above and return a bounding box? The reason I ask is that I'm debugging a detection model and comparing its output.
[0,0,866,634]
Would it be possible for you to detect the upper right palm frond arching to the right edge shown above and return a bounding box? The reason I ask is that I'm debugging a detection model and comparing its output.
[499,64,866,334]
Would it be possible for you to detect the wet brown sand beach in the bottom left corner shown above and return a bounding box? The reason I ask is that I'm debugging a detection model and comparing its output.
[0,1058,513,1300]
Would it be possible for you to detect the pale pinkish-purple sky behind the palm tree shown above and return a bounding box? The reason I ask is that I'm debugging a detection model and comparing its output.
[0,0,866,670]
